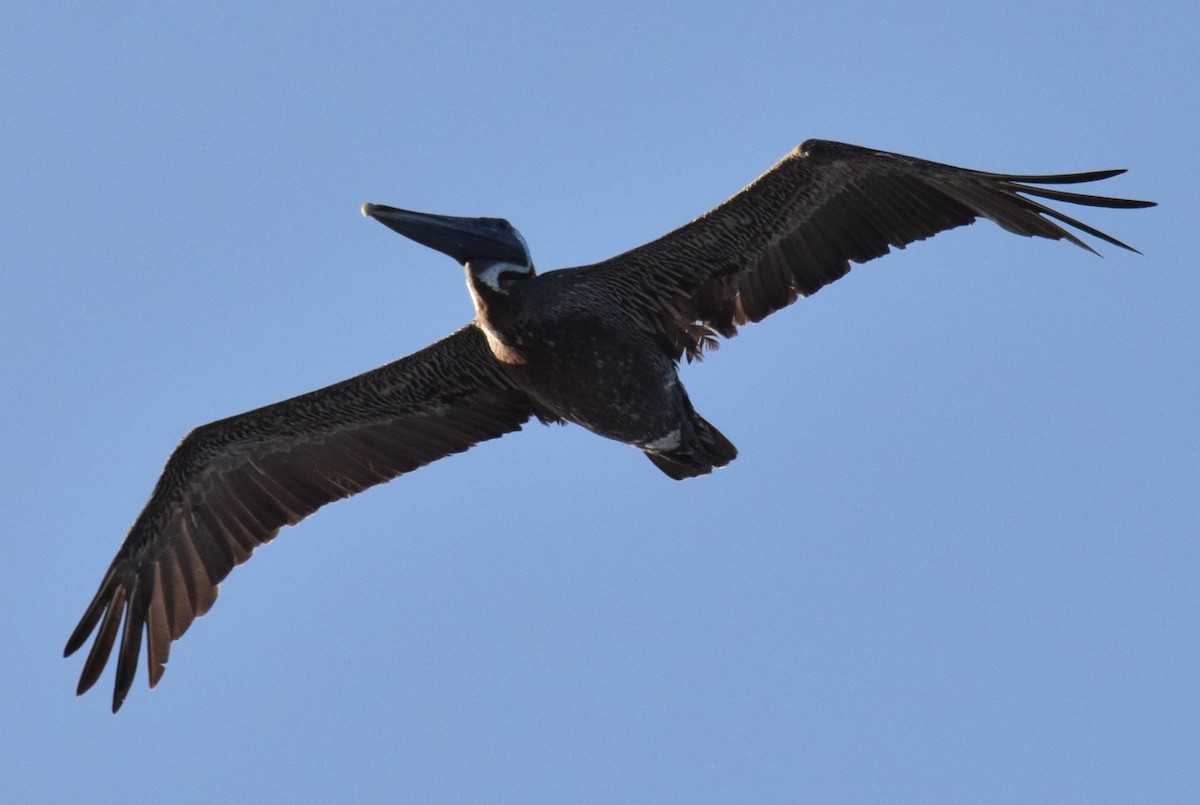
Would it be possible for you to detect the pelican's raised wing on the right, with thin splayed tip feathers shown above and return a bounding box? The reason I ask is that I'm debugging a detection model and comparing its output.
[581,140,1154,359]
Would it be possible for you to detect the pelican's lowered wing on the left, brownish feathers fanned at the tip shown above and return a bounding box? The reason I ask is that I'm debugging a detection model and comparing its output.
[64,325,533,713]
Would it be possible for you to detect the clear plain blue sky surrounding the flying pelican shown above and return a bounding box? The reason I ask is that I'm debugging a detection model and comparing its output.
[0,0,1200,803]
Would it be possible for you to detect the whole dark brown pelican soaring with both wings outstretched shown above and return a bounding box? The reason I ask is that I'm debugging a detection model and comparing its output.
[65,140,1153,713]
